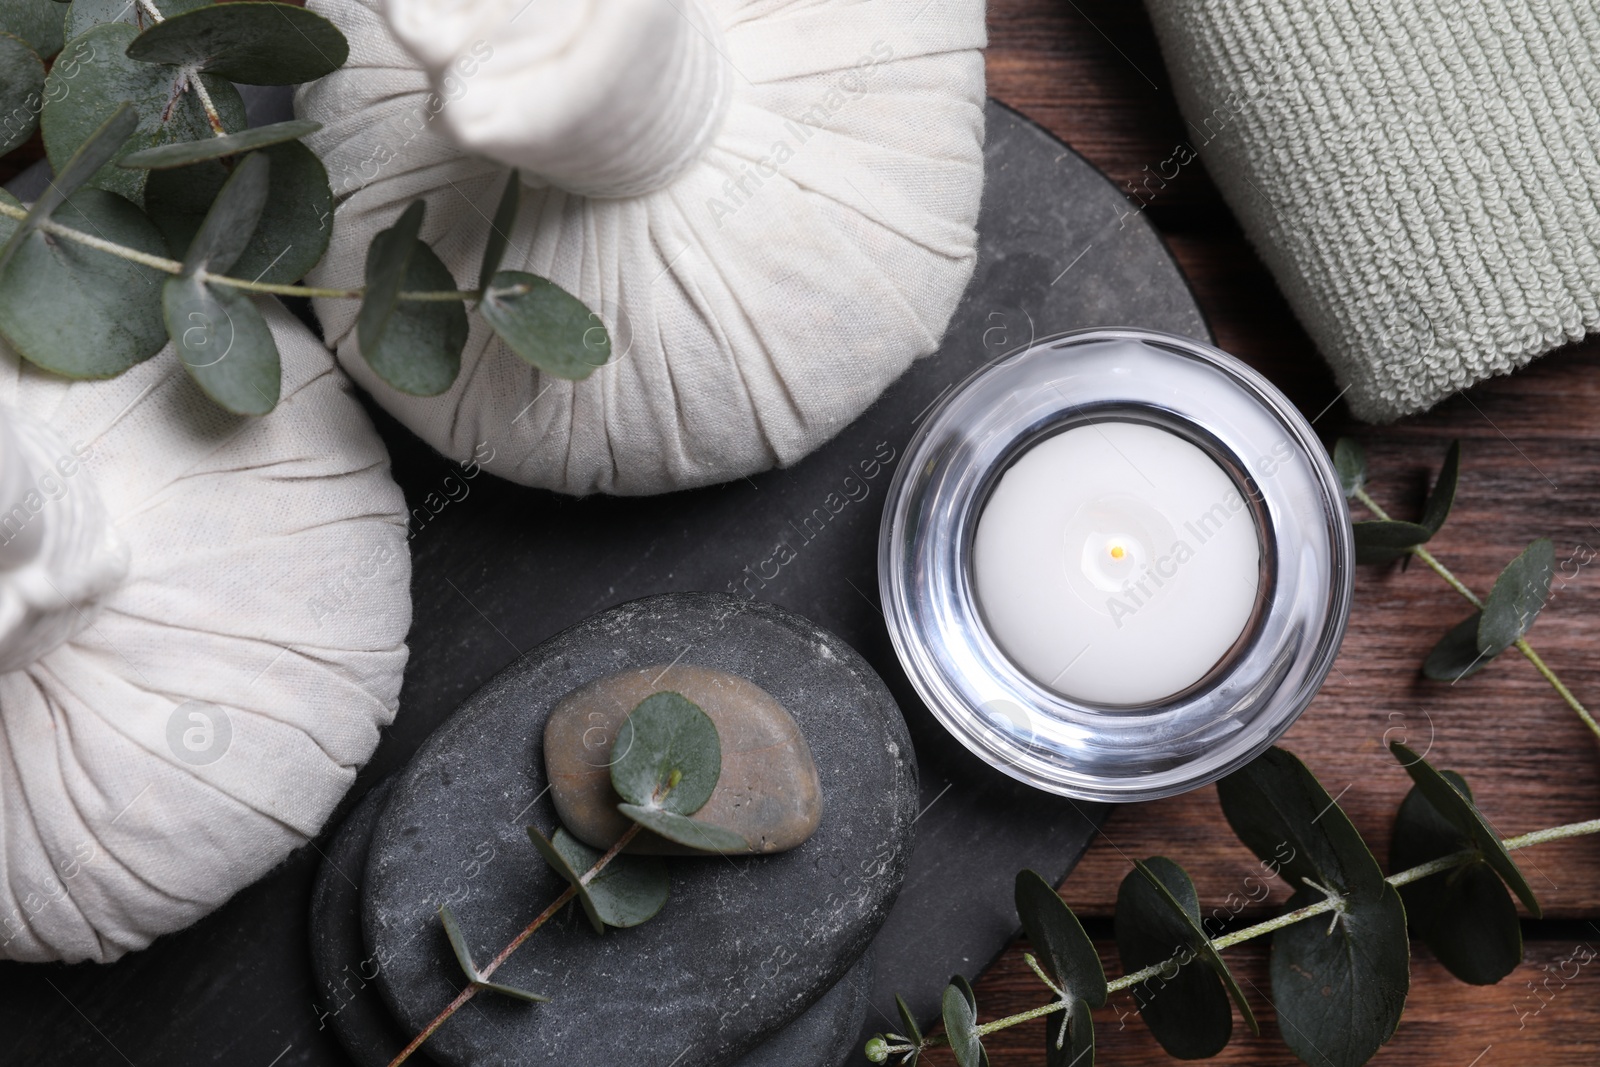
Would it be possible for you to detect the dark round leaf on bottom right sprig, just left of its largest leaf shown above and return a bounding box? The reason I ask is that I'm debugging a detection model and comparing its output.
[1115,856,1261,1059]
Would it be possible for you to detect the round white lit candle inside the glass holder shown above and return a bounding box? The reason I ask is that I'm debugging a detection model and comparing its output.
[973,422,1261,705]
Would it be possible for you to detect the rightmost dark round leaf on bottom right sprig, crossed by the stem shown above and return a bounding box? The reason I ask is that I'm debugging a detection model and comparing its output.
[1389,771,1522,985]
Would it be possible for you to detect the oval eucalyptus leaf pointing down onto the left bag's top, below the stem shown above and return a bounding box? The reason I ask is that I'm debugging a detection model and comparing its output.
[162,275,282,414]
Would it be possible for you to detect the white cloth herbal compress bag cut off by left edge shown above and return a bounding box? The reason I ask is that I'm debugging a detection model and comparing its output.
[0,304,411,961]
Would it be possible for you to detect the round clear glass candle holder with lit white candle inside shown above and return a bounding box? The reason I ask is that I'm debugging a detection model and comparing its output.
[878,330,1354,801]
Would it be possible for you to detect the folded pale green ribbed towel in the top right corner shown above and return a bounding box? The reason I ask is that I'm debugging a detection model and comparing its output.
[1146,0,1600,421]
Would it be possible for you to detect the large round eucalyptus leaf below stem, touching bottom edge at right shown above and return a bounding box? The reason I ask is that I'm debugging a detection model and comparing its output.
[1270,883,1411,1067]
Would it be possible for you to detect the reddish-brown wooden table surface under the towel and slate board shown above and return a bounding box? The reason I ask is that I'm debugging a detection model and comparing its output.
[925,0,1600,1067]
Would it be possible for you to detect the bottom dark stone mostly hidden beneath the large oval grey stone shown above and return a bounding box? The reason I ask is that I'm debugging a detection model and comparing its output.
[310,777,872,1067]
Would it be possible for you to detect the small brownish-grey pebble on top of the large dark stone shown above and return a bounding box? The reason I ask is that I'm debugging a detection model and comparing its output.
[544,664,822,856]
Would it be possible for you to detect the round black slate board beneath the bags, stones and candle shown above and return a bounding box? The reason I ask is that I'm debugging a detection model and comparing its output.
[0,101,1210,1067]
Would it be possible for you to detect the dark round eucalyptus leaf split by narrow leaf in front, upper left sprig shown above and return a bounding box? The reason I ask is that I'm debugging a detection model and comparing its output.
[144,138,333,283]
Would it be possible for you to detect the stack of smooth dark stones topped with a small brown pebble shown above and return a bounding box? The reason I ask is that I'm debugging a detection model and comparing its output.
[312,593,917,1067]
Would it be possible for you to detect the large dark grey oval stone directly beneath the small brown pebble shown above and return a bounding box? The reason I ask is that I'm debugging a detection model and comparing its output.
[362,593,917,1067]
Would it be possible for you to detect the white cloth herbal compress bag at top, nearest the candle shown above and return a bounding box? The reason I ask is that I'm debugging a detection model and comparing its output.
[296,0,984,494]
